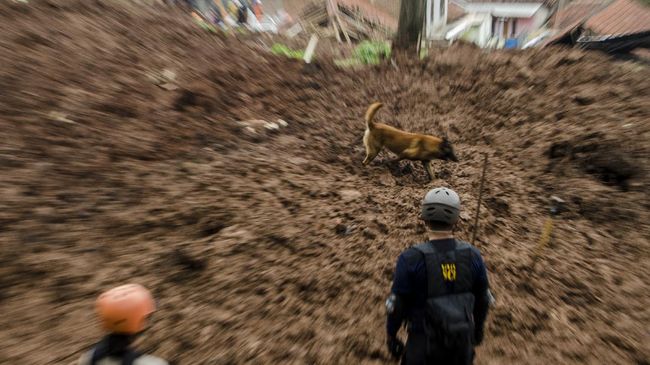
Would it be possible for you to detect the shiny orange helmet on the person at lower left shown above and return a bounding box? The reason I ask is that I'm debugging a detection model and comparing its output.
[95,284,156,335]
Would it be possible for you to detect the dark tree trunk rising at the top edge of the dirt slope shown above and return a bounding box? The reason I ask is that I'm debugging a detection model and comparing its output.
[393,0,427,51]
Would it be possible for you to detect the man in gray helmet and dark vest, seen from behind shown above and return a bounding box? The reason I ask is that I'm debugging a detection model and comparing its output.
[386,188,491,365]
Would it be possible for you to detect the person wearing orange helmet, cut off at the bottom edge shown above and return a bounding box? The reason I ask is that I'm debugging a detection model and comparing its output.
[79,284,168,365]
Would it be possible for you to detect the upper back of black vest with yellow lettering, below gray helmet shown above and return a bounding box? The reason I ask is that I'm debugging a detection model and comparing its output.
[413,240,472,298]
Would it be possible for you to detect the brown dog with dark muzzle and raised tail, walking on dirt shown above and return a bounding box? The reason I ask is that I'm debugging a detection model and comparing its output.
[363,103,458,180]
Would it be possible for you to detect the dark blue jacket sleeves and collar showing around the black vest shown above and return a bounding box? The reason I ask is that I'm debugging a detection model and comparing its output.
[386,239,489,336]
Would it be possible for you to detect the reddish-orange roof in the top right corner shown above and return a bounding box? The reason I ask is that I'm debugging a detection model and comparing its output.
[585,0,650,35]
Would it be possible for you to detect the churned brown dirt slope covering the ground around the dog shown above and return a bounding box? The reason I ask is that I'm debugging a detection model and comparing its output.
[0,0,650,364]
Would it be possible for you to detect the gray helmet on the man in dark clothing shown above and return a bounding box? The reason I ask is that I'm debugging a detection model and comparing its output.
[421,188,460,225]
